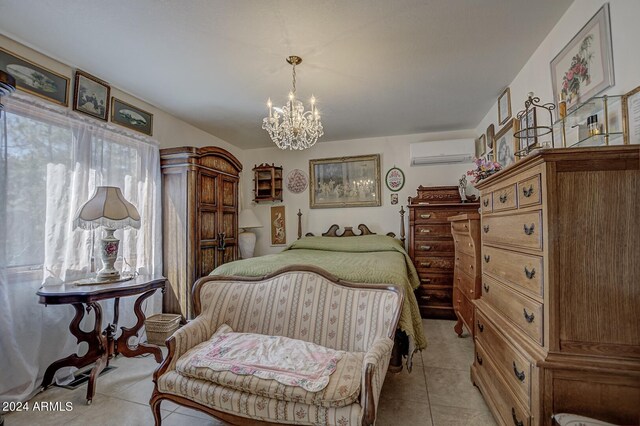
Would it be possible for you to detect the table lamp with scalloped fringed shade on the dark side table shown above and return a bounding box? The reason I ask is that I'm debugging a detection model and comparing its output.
[74,186,140,282]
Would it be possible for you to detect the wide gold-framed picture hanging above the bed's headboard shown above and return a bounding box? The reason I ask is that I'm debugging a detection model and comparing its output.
[309,154,382,209]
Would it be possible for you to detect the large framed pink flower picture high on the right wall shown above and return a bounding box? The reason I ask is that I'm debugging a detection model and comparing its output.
[551,3,614,112]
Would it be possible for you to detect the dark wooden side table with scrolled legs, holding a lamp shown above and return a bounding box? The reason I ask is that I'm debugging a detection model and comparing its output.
[36,275,166,404]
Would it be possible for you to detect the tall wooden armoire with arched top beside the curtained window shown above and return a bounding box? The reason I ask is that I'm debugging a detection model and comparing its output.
[160,147,242,319]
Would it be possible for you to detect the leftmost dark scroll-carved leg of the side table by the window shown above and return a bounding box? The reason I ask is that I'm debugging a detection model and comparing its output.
[42,303,102,390]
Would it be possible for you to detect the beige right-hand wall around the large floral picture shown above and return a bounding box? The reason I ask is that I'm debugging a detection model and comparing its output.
[476,0,640,146]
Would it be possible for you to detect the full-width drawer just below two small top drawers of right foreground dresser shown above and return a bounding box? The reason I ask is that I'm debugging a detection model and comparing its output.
[481,210,542,250]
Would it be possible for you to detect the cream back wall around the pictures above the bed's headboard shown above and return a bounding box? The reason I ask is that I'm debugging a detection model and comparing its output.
[242,130,474,256]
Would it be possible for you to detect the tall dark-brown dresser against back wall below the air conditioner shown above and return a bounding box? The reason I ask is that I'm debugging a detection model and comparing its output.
[409,186,479,319]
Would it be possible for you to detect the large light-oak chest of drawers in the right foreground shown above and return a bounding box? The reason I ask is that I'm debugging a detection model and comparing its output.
[471,145,640,425]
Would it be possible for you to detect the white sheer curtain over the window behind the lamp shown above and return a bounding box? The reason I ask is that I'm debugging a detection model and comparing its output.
[0,94,162,401]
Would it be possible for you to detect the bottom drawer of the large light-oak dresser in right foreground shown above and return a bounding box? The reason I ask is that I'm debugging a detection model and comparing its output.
[473,340,531,426]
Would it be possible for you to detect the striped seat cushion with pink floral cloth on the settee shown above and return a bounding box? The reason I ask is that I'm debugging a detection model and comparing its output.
[176,325,364,407]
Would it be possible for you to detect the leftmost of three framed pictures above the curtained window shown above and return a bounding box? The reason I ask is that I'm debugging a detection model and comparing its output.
[0,48,70,106]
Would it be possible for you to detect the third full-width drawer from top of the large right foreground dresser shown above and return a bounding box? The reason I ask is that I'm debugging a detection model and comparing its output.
[482,275,543,345]
